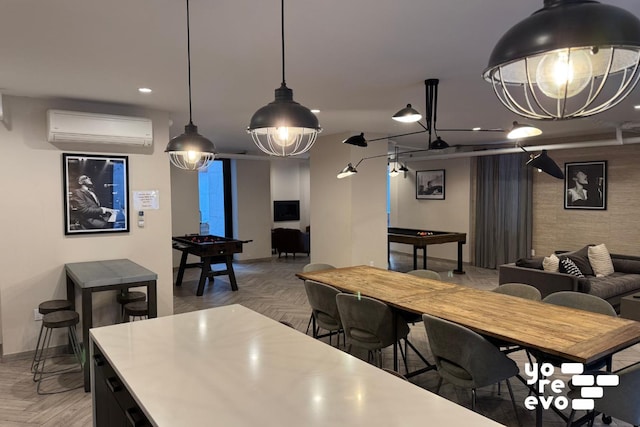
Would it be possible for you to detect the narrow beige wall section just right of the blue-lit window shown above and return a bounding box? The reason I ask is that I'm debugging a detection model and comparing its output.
[231,160,273,260]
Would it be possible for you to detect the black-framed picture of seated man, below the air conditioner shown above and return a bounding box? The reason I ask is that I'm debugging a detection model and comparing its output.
[62,153,129,235]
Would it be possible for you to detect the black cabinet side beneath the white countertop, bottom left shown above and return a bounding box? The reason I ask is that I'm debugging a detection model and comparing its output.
[93,345,151,427]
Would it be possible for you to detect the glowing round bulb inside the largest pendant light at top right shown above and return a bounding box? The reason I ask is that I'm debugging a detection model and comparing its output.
[536,48,593,99]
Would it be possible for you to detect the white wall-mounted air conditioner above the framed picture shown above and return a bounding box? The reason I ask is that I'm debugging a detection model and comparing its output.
[47,110,153,147]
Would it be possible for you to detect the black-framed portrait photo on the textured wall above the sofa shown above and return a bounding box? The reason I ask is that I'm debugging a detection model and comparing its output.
[564,160,607,210]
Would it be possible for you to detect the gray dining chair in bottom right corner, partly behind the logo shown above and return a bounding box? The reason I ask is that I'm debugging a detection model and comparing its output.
[567,363,640,427]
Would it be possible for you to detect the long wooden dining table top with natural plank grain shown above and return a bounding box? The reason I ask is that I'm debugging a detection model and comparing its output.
[297,265,640,364]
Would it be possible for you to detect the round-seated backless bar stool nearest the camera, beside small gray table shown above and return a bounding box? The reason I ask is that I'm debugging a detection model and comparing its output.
[33,310,83,394]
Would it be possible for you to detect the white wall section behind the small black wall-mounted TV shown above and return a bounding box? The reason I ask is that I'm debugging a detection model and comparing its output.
[271,157,309,230]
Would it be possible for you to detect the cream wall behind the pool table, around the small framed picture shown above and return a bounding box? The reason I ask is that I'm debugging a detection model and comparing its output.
[389,158,471,262]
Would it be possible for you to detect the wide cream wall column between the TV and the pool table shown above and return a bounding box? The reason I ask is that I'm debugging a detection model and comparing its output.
[310,134,387,268]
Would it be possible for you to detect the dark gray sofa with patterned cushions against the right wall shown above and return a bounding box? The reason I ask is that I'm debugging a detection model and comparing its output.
[498,245,640,312]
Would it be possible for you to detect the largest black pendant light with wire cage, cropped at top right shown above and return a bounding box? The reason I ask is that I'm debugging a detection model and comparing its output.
[483,0,640,120]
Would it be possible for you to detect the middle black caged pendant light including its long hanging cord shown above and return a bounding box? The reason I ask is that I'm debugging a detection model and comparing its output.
[247,0,322,157]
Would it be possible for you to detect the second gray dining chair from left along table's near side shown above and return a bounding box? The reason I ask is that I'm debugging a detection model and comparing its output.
[336,293,409,369]
